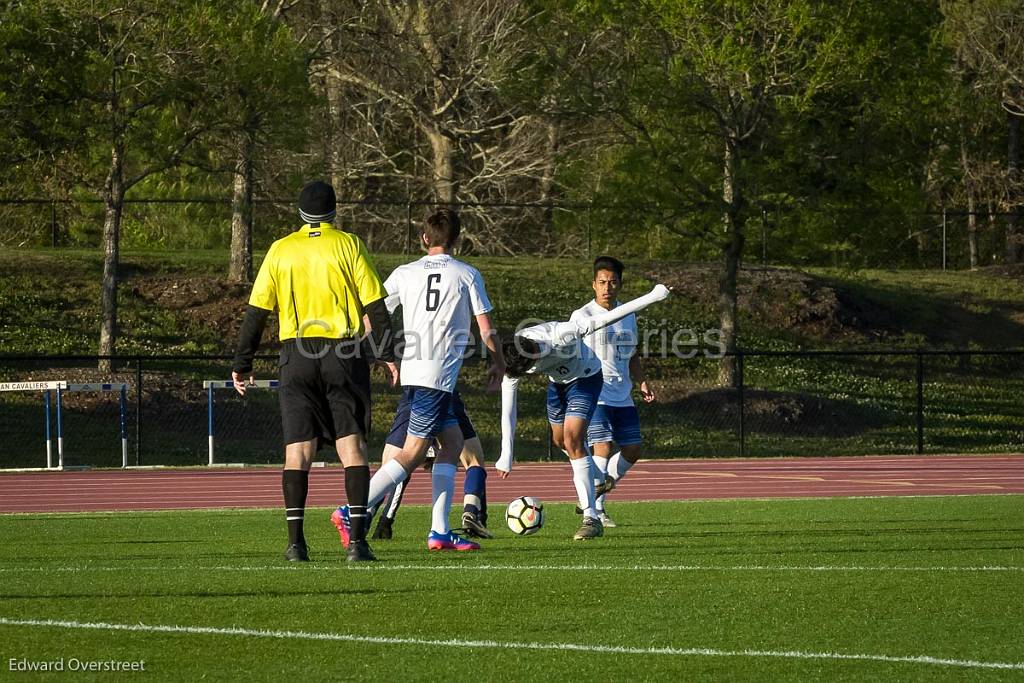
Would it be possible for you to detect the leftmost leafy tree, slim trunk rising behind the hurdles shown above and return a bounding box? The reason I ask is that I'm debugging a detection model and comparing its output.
[10,0,218,370]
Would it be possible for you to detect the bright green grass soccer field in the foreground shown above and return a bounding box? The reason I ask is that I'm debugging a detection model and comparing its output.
[0,496,1024,681]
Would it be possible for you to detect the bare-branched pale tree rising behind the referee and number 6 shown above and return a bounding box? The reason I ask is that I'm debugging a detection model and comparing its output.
[323,0,549,254]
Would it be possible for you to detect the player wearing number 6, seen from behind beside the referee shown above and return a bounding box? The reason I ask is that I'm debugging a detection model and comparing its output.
[332,209,505,550]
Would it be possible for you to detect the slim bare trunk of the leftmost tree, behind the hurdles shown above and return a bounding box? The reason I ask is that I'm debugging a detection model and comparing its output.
[99,145,125,373]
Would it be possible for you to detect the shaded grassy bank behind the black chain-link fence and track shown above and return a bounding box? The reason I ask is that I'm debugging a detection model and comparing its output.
[0,245,1024,464]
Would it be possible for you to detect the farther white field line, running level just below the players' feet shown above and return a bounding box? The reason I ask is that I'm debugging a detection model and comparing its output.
[0,563,1024,573]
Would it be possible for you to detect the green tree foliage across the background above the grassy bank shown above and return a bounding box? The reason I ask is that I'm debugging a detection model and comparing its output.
[0,0,1021,268]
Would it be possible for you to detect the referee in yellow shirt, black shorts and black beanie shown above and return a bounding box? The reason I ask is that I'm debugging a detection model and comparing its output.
[231,180,398,562]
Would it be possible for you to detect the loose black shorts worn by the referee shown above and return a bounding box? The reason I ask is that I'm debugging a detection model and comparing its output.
[278,338,370,445]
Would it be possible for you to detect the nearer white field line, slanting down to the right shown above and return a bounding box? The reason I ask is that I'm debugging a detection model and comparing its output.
[0,616,1024,670]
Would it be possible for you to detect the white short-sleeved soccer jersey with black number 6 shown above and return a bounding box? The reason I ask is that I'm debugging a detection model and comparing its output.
[384,254,493,392]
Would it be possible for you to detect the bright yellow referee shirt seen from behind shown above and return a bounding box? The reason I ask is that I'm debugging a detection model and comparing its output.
[249,223,387,341]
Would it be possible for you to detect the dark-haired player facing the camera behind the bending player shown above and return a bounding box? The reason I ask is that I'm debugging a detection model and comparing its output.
[569,256,654,527]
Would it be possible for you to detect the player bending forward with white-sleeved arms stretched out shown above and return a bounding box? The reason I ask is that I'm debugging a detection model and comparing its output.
[495,285,669,541]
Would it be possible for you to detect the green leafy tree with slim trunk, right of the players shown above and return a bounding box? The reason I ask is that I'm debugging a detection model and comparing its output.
[592,0,850,386]
